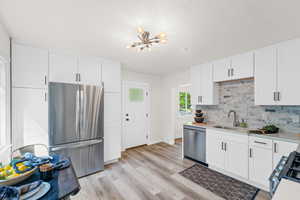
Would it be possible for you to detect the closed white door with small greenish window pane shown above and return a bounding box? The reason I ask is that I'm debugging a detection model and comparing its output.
[123,82,150,149]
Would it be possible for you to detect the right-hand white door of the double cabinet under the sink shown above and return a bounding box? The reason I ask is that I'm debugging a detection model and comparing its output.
[225,141,248,179]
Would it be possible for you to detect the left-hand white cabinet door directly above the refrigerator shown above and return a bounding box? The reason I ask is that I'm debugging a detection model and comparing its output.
[49,53,78,83]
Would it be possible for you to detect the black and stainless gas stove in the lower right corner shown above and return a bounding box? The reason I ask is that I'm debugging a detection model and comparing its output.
[269,151,300,195]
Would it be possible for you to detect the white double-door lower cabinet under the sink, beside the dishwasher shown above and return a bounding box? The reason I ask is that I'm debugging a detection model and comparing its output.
[206,129,248,179]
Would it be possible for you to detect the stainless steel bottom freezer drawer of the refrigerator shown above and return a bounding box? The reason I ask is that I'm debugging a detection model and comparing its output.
[50,139,104,177]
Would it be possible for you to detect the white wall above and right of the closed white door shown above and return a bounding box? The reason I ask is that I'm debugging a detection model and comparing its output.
[122,69,163,144]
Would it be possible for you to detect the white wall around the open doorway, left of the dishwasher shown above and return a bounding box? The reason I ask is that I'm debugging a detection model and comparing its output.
[161,70,190,144]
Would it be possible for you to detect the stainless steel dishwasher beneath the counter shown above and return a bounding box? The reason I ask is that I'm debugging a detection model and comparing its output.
[183,125,207,165]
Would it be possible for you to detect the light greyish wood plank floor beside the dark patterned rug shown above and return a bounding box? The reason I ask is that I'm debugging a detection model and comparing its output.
[72,141,270,200]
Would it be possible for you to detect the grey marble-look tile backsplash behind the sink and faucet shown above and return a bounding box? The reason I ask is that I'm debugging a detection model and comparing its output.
[197,80,300,133]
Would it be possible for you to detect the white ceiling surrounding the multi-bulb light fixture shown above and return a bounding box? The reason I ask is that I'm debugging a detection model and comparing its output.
[0,0,300,75]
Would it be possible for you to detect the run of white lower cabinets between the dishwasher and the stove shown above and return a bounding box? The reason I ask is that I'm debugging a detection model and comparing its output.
[206,128,299,190]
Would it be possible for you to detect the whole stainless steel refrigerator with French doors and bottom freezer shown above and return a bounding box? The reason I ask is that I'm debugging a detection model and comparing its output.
[49,82,104,177]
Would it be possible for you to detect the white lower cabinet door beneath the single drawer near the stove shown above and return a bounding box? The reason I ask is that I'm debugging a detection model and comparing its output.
[249,146,273,188]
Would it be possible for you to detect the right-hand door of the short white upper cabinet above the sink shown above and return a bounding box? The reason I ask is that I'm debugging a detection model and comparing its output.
[231,52,254,79]
